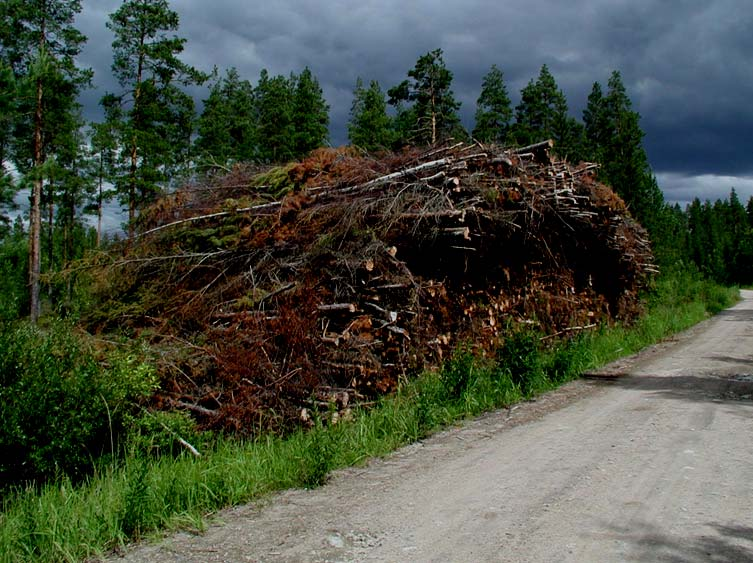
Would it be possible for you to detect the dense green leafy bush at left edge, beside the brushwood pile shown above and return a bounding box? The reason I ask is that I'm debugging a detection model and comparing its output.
[0,322,156,485]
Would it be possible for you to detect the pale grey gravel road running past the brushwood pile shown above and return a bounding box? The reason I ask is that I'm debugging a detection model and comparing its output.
[113,291,753,563]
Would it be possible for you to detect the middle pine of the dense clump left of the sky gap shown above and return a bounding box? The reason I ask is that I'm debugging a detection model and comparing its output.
[255,69,295,162]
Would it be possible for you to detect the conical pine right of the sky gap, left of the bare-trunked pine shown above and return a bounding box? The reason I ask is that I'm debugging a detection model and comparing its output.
[348,78,393,152]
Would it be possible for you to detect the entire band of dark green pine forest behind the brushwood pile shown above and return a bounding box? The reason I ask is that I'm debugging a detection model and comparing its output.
[0,25,753,326]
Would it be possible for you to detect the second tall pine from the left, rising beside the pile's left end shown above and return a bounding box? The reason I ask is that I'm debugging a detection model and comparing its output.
[102,0,207,236]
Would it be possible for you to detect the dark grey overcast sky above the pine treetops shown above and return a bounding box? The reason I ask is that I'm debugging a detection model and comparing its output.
[72,0,753,207]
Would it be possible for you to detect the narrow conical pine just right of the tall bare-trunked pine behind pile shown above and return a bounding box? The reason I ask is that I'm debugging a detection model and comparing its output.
[473,65,512,144]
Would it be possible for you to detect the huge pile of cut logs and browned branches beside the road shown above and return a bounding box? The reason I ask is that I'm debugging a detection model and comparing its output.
[86,142,656,433]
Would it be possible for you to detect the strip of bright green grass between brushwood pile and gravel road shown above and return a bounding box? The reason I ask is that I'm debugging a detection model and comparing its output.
[0,274,737,563]
